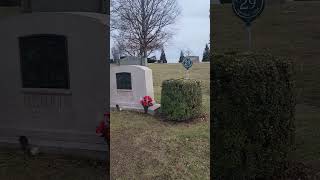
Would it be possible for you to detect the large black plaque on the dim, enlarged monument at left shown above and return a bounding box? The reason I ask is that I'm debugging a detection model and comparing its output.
[19,35,70,89]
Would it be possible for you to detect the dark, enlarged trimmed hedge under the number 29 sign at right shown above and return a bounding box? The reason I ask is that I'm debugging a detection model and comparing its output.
[211,53,295,179]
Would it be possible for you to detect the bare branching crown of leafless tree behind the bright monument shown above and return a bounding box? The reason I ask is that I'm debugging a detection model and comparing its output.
[111,0,180,58]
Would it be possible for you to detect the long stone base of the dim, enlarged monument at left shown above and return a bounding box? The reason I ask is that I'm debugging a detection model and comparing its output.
[0,128,109,161]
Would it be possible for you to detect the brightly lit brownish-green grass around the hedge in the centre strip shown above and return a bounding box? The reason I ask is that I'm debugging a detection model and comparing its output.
[111,64,210,179]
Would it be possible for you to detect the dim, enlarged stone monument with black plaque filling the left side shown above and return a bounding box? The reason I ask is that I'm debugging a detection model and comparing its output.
[0,0,110,159]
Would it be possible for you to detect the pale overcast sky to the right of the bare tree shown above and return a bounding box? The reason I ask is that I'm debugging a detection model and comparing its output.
[111,0,210,63]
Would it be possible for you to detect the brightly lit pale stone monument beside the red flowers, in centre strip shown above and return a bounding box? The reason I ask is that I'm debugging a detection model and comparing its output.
[110,58,160,113]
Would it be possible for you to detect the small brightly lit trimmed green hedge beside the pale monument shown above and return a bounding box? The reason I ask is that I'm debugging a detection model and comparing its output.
[161,79,202,121]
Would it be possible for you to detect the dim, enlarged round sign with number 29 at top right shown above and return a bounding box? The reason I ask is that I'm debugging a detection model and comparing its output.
[232,0,265,24]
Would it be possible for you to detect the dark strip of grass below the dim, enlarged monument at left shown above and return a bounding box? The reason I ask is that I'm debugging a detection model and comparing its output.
[0,149,107,180]
